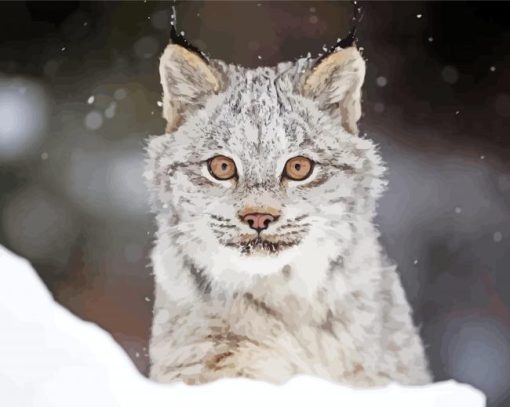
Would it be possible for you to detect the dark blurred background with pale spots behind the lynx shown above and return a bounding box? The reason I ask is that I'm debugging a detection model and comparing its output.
[0,1,510,407]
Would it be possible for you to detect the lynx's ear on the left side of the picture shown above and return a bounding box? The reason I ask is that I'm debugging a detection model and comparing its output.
[159,44,221,132]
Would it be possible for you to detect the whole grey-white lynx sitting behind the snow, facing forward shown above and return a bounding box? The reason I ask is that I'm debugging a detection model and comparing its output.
[145,36,431,386]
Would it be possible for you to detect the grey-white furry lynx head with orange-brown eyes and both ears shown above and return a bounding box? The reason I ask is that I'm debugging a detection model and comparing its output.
[146,45,383,292]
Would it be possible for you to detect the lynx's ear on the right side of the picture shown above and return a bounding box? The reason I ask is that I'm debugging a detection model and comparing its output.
[303,47,365,134]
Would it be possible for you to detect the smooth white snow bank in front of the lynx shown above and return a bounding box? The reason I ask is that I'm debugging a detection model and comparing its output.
[0,246,485,407]
